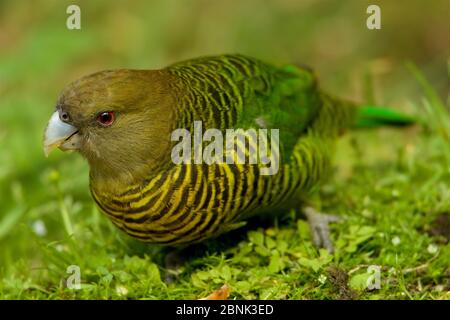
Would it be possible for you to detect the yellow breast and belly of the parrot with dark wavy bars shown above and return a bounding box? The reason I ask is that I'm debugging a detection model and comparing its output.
[91,137,328,245]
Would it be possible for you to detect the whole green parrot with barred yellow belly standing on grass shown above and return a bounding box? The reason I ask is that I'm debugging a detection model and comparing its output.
[44,55,413,251]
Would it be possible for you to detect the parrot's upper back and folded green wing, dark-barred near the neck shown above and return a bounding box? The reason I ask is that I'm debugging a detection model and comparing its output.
[168,55,322,157]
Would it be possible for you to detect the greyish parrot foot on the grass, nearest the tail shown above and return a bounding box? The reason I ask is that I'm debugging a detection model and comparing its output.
[303,207,341,253]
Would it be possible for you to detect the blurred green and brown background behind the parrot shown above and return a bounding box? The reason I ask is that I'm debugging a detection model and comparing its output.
[0,0,450,297]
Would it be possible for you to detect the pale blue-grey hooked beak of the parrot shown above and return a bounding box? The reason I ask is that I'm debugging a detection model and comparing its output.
[44,111,81,157]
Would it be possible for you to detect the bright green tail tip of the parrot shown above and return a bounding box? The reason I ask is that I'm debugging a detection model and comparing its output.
[353,106,417,128]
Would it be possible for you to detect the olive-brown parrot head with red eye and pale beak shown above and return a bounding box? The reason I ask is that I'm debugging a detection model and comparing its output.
[44,70,174,185]
